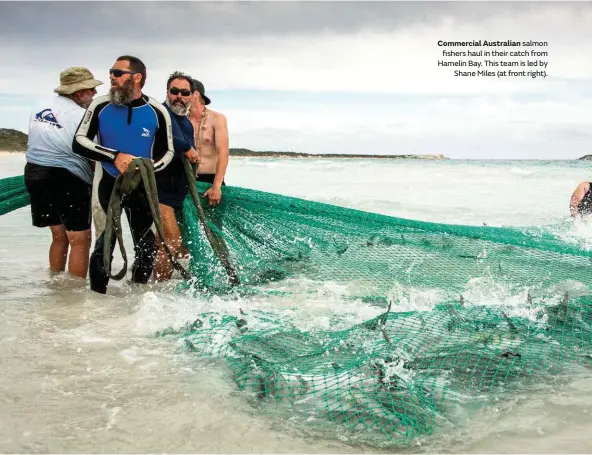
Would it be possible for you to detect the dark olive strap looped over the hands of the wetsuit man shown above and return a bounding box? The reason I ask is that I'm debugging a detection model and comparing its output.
[103,158,192,280]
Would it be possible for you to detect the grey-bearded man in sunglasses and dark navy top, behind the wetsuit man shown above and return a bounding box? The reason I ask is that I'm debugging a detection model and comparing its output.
[154,71,199,281]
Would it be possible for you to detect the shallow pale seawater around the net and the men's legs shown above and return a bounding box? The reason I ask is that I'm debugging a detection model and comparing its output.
[0,155,592,453]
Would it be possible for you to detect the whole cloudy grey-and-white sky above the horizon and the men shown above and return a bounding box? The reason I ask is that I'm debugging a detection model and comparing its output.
[0,1,592,159]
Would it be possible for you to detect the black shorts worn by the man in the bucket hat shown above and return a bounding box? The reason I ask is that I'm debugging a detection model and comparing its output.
[25,163,92,231]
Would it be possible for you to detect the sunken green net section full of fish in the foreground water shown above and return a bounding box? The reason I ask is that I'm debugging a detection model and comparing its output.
[185,297,592,447]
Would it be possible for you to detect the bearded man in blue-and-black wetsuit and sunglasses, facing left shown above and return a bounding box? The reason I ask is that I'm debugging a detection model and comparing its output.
[73,55,174,294]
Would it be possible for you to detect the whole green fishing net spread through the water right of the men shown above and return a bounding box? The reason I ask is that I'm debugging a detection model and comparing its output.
[181,183,592,446]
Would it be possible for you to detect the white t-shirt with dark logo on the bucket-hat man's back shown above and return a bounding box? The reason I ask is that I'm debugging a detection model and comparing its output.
[26,95,93,184]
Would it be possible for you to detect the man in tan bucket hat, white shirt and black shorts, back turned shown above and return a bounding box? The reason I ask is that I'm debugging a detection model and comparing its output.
[25,67,102,278]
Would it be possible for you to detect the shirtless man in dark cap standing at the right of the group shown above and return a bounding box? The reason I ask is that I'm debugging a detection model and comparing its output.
[188,79,228,205]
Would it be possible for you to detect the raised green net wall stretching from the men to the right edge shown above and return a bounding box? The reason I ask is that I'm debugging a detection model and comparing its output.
[181,183,592,301]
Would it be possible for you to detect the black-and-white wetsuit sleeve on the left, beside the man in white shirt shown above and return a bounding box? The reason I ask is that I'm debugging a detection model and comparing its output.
[72,97,119,163]
